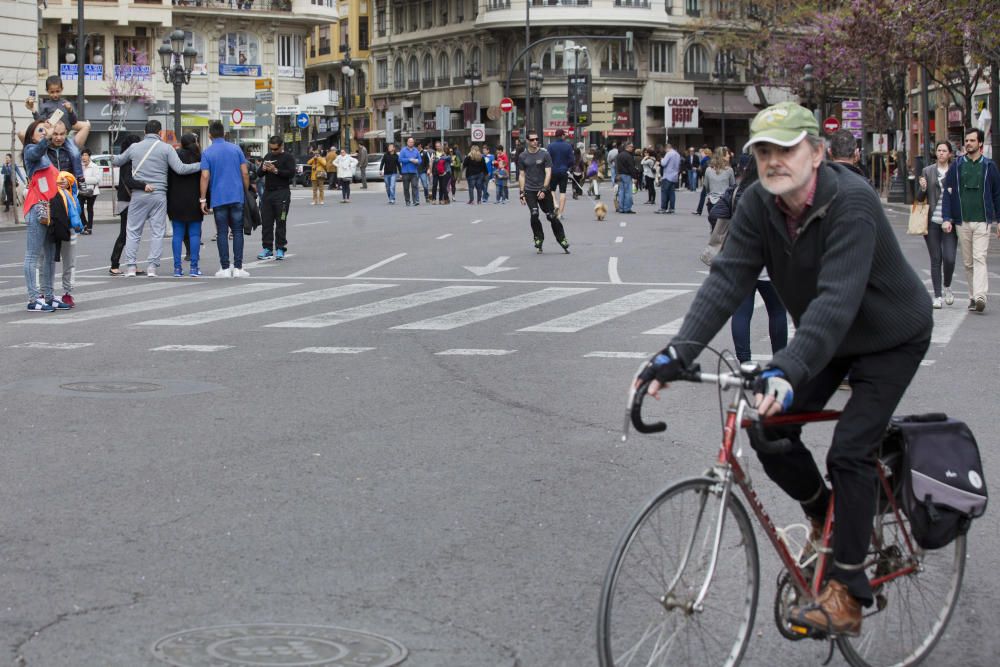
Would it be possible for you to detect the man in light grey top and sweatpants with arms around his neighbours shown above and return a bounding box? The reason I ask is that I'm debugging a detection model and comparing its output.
[113,120,201,277]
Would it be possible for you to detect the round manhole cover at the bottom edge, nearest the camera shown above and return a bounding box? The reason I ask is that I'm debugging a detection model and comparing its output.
[153,623,406,667]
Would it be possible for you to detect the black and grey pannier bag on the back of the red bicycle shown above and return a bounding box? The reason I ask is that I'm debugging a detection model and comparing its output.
[882,413,988,549]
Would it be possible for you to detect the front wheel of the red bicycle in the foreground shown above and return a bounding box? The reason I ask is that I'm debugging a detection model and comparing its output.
[597,479,759,667]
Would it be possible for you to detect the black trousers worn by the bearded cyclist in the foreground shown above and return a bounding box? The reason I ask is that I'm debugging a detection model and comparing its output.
[758,337,930,606]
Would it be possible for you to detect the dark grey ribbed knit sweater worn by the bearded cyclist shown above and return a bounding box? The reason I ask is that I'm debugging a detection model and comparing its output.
[671,163,933,387]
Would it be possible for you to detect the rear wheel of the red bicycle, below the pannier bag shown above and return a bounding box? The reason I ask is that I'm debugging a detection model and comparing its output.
[837,512,966,667]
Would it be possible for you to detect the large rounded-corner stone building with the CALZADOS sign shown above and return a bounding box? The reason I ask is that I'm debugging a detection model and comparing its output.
[371,0,768,153]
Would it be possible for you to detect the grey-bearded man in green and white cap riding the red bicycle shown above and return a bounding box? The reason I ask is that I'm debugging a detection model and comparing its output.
[639,102,933,634]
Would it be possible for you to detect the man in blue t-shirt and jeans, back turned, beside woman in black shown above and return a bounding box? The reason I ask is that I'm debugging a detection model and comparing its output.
[199,120,250,278]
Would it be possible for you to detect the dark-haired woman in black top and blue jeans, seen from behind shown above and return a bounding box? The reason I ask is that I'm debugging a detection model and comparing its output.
[167,132,204,278]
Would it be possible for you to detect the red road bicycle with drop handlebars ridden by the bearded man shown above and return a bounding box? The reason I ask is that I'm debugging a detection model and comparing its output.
[597,355,966,667]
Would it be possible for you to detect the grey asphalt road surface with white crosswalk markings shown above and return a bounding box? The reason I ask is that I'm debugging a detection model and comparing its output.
[0,184,1000,667]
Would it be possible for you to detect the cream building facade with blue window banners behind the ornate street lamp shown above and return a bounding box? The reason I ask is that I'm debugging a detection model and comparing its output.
[37,0,338,152]
